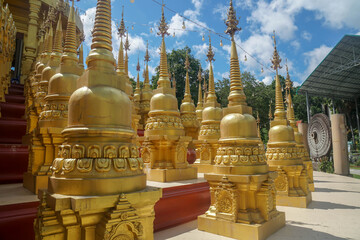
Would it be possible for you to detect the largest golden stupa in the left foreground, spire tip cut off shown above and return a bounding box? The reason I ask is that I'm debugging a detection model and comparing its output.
[34,0,161,240]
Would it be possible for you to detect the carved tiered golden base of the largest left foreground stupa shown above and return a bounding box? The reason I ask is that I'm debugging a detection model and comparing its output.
[34,187,162,240]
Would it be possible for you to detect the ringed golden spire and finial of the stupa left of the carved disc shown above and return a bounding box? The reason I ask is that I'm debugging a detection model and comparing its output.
[271,31,286,120]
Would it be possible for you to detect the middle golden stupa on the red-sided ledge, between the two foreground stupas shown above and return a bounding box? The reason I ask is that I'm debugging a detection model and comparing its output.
[141,6,197,182]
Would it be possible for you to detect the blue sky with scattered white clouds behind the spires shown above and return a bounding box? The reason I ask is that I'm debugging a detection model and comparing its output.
[76,0,360,85]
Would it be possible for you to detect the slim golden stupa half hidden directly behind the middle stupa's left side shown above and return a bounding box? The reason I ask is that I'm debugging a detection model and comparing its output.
[139,43,153,129]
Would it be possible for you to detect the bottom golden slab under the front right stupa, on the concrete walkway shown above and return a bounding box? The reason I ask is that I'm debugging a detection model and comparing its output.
[198,212,285,240]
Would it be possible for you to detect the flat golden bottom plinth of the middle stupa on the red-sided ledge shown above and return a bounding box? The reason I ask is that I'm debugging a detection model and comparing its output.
[145,167,197,182]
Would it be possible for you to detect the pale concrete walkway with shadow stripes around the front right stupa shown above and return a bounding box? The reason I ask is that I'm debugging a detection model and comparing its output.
[154,172,360,240]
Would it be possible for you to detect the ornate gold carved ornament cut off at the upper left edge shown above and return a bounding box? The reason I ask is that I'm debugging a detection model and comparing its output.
[0,0,16,117]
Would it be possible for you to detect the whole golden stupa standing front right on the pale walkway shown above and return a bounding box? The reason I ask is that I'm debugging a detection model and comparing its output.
[198,0,285,240]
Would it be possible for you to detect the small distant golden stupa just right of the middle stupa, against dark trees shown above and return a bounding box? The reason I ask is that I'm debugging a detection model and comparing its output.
[180,53,200,146]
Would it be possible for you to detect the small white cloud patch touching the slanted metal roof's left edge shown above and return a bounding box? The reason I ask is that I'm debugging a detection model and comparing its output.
[302,45,332,81]
